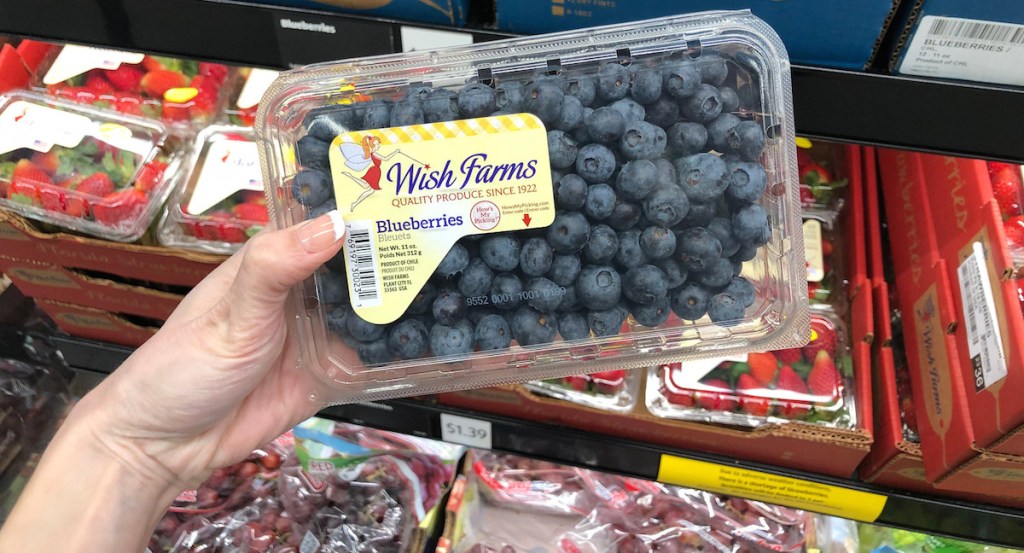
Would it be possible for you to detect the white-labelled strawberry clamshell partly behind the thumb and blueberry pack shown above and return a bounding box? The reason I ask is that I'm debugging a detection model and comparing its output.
[158,126,269,254]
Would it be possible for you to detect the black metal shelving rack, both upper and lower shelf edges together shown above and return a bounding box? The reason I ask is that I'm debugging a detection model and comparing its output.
[6,0,1024,546]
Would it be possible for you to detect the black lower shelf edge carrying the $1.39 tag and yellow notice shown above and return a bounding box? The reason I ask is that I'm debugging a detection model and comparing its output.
[53,336,1024,546]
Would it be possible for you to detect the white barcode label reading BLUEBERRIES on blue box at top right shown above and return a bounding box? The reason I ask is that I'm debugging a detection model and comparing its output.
[899,15,1024,85]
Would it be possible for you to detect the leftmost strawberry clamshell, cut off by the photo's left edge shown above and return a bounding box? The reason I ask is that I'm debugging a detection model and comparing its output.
[0,91,179,242]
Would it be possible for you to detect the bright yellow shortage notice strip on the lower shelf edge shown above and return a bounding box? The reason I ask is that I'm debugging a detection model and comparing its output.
[657,455,886,522]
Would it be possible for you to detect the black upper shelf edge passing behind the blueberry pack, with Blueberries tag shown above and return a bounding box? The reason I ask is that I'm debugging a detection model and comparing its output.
[0,0,1024,162]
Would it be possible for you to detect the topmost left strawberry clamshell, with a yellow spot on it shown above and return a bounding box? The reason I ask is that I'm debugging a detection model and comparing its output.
[36,44,230,126]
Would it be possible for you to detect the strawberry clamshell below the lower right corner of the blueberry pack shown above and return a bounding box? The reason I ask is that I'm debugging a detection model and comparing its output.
[646,309,857,428]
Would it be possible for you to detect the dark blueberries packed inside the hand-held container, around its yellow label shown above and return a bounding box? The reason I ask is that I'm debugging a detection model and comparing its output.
[292,50,771,366]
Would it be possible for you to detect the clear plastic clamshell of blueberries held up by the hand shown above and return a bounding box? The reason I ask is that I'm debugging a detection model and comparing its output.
[255,11,809,402]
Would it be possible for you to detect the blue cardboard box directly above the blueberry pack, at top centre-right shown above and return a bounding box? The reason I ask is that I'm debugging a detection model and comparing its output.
[495,0,899,70]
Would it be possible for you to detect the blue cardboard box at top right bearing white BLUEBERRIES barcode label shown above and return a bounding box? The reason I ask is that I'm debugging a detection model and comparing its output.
[889,0,1024,86]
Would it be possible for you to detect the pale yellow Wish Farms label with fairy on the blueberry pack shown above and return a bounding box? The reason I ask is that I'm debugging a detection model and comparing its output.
[330,114,555,325]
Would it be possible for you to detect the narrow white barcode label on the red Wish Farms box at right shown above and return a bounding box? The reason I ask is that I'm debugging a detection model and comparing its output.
[956,242,1007,392]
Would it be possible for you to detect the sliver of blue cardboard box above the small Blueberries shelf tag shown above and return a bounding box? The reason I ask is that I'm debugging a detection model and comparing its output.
[241,0,470,27]
